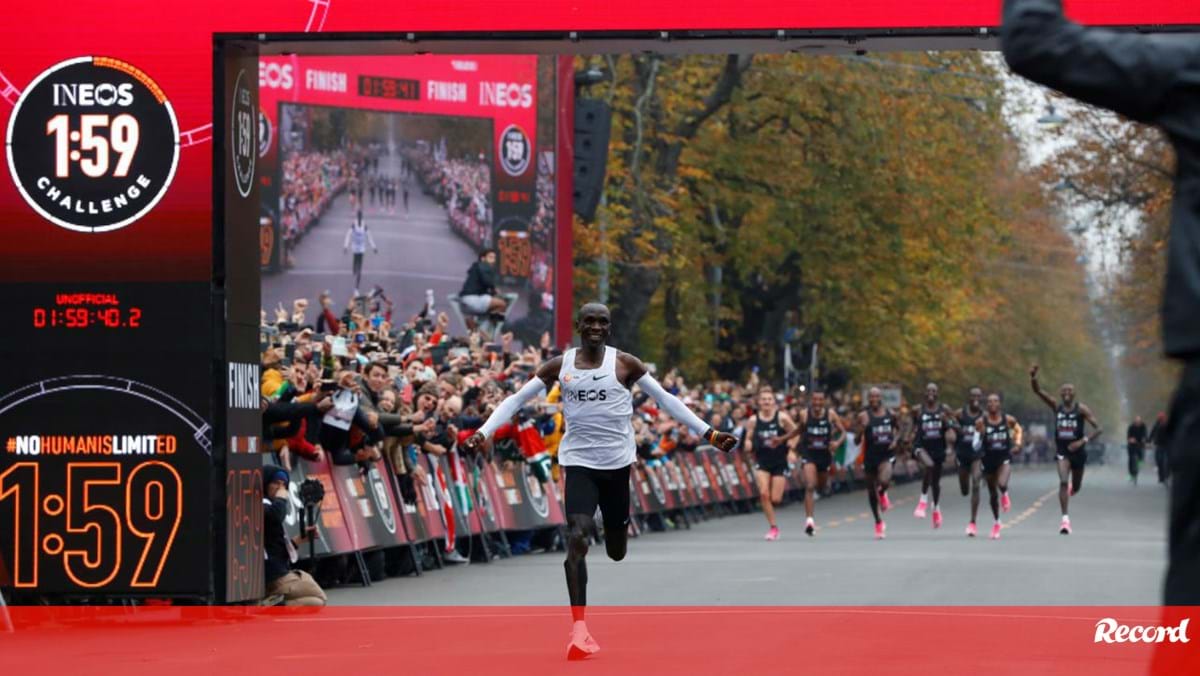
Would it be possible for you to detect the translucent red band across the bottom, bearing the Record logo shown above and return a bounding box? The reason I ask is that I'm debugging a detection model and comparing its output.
[0,606,1200,676]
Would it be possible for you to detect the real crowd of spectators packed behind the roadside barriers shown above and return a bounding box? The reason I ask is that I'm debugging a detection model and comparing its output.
[255,287,974,521]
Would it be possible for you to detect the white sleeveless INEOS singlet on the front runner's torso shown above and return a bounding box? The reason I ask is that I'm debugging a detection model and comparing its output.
[558,347,637,469]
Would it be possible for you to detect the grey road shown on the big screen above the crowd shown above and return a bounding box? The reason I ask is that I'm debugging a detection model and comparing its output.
[262,155,526,335]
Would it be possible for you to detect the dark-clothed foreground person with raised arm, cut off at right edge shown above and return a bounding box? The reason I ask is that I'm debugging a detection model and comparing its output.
[1001,0,1200,605]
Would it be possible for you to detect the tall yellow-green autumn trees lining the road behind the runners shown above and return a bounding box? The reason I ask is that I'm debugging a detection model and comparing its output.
[576,53,1112,422]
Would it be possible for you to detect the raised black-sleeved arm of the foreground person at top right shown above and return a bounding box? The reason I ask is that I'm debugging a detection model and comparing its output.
[1001,0,1200,122]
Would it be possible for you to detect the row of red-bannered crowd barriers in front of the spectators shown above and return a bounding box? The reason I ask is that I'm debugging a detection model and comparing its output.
[263,447,768,585]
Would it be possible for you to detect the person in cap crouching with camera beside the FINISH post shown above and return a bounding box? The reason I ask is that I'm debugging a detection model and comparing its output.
[263,466,325,606]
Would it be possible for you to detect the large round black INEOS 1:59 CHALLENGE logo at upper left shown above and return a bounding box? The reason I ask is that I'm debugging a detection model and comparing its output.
[6,56,179,233]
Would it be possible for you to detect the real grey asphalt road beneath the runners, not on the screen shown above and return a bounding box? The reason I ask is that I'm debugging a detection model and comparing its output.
[330,463,1166,605]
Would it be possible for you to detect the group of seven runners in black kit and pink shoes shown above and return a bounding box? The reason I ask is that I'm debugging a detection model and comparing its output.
[745,365,1103,540]
